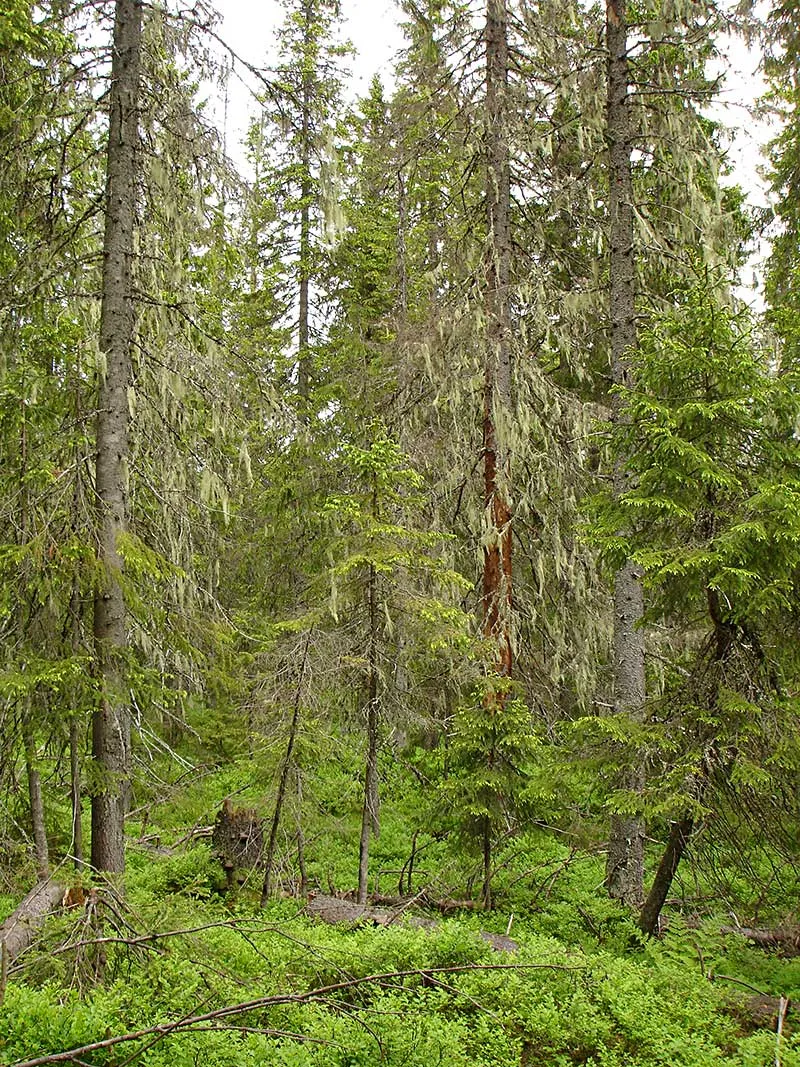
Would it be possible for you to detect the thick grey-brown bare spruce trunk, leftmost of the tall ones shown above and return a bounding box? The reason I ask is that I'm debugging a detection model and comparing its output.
[92,0,142,872]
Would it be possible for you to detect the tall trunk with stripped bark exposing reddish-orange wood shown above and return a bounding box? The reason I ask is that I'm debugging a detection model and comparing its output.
[482,0,513,678]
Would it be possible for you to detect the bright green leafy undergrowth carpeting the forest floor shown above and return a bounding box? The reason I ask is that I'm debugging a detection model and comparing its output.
[0,760,800,1067]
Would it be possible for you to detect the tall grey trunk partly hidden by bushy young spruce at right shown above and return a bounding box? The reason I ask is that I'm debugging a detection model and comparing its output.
[606,0,645,907]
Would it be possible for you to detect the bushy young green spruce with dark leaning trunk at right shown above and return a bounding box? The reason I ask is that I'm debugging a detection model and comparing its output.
[605,270,800,934]
